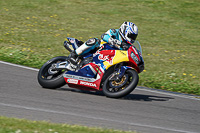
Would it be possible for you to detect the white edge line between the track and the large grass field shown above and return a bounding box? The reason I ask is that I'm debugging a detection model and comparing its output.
[0,61,200,100]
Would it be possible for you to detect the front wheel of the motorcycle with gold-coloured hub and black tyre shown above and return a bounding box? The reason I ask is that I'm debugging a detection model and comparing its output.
[103,69,139,98]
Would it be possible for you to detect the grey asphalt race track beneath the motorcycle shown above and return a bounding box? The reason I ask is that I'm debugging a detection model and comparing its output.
[0,61,200,133]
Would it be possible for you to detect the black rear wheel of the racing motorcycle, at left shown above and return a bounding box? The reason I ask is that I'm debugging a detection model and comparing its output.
[38,56,67,89]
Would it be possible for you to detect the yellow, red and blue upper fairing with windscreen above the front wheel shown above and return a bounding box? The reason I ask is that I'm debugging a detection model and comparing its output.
[93,41,144,73]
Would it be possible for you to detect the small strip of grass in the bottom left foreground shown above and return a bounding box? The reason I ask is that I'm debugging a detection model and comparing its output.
[0,116,135,133]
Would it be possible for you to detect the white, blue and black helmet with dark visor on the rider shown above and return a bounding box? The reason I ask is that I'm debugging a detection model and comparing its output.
[119,22,138,44]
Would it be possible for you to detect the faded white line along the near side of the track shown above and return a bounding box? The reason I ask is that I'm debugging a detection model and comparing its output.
[0,103,197,133]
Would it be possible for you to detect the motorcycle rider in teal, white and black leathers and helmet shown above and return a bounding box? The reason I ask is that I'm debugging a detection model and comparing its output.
[69,22,138,65]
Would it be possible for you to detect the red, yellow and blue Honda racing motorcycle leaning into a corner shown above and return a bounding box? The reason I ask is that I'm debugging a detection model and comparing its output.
[38,37,144,98]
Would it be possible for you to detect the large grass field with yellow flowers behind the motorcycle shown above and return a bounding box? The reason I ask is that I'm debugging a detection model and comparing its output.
[0,0,200,95]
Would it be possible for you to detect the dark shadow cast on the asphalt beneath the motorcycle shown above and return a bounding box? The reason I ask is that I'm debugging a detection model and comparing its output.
[57,87,174,102]
